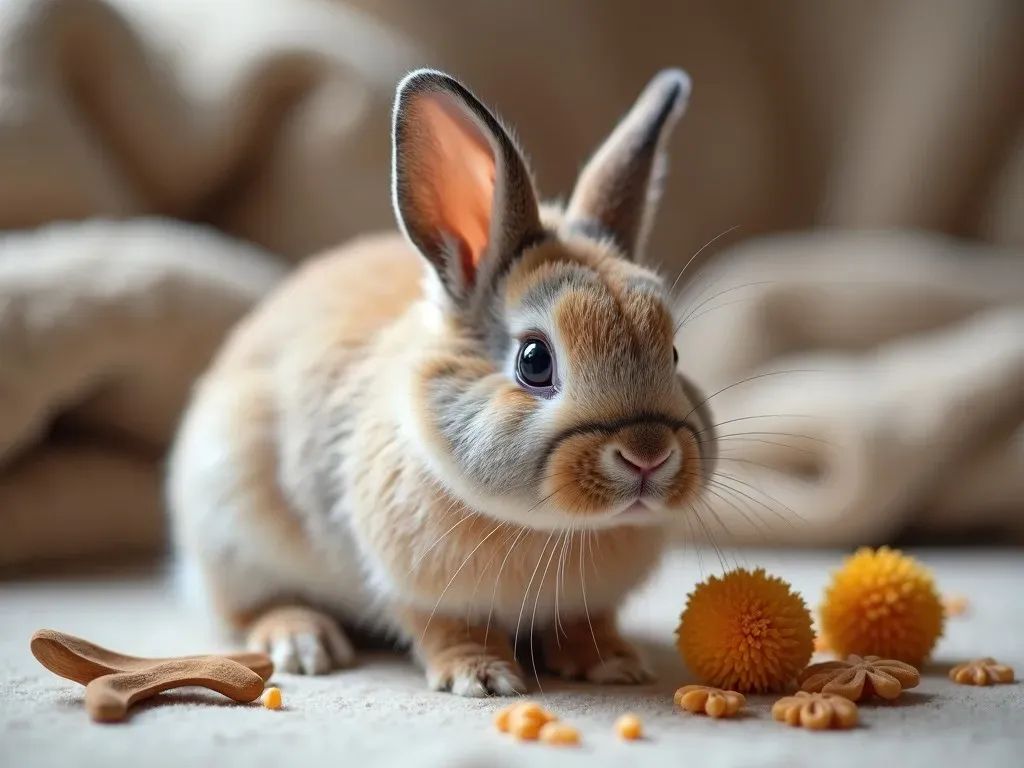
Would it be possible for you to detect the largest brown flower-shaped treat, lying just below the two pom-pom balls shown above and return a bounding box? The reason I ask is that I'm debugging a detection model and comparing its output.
[800,654,921,701]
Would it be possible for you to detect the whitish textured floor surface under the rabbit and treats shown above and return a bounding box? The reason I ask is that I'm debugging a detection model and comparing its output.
[0,550,1024,768]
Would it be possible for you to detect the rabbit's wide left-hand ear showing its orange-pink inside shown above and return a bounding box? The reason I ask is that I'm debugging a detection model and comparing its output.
[392,70,543,303]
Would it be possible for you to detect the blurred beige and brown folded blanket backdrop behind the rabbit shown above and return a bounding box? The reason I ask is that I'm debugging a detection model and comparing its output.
[0,0,1024,567]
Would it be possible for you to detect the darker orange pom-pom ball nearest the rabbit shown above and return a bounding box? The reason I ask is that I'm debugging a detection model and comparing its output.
[676,568,814,693]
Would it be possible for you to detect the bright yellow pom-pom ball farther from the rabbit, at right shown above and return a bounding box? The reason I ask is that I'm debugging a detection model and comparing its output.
[818,547,945,666]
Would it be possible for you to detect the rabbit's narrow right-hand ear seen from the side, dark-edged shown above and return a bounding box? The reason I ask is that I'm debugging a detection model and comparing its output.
[563,69,690,259]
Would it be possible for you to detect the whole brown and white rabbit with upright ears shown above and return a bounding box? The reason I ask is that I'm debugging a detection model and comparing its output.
[168,70,715,696]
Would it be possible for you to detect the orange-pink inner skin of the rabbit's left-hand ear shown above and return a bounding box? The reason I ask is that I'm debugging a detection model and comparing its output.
[416,94,496,282]
